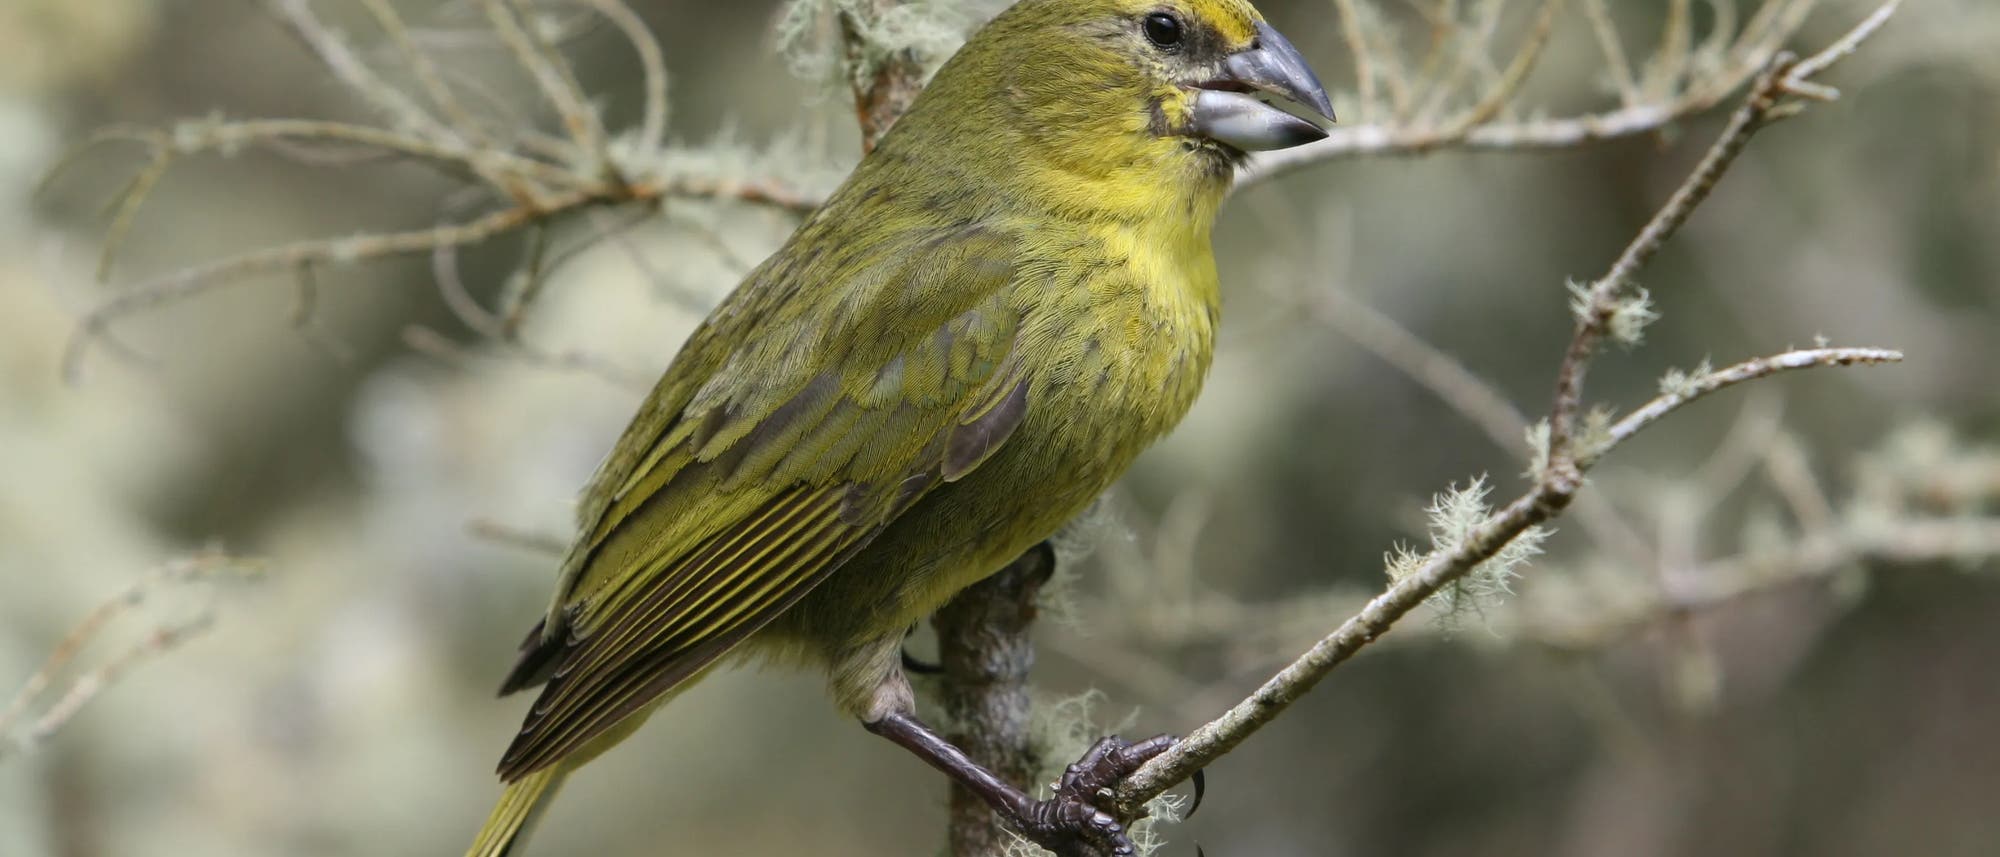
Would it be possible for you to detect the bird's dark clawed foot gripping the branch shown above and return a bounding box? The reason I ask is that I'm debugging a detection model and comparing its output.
[1012,735,1180,857]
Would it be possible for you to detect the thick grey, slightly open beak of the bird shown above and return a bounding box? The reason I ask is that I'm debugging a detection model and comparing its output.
[1192,22,1334,152]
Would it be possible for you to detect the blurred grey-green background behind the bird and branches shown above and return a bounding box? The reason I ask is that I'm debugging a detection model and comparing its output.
[0,0,2000,857]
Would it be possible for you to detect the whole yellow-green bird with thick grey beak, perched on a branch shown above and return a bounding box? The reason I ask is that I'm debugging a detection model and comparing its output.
[470,0,1332,857]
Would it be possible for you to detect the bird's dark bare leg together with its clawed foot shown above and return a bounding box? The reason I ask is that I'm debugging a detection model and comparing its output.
[866,711,1178,857]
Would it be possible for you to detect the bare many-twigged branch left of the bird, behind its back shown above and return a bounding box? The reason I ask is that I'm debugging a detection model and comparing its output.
[44,0,822,382]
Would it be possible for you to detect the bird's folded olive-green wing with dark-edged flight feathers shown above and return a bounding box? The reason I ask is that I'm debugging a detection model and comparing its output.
[500,228,1028,779]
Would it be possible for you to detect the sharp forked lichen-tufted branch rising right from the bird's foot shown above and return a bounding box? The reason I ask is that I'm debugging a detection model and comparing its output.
[1116,0,1902,817]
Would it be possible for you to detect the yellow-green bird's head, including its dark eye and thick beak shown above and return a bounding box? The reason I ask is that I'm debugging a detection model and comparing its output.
[884,0,1334,217]
